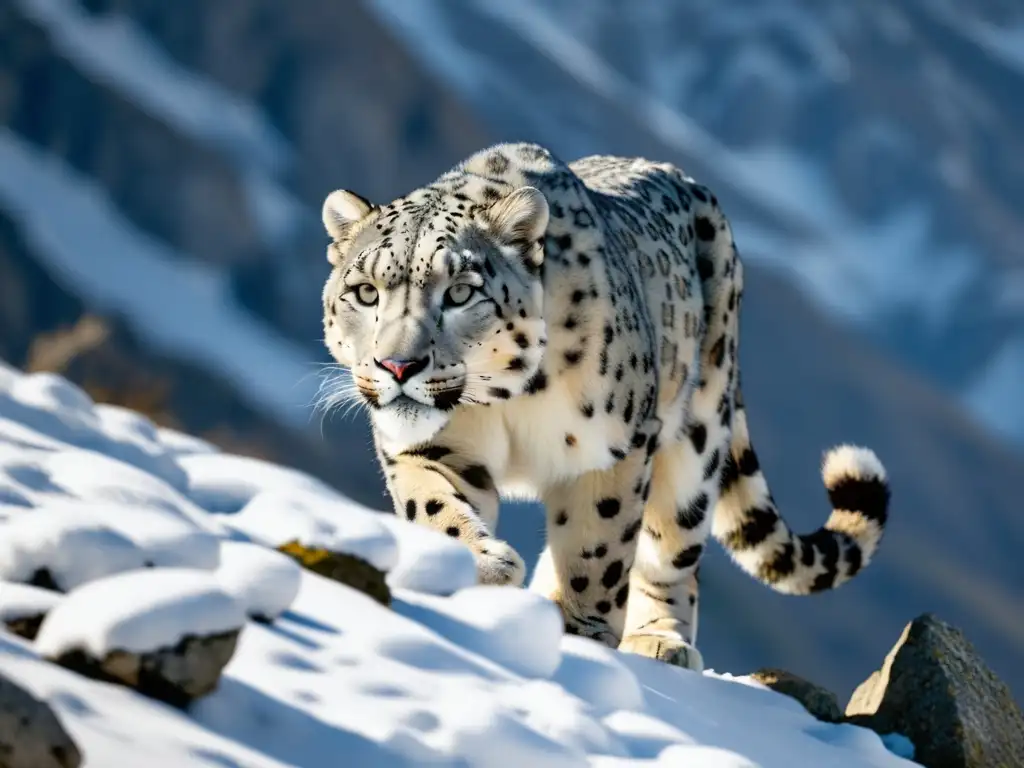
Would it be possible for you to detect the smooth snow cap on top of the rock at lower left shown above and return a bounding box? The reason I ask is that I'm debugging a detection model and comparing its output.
[36,568,246,658]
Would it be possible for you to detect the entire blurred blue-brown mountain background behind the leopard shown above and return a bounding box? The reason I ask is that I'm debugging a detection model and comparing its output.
[0,0,1024,698]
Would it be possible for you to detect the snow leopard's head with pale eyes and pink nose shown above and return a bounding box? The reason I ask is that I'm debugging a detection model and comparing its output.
[323,180,548,450]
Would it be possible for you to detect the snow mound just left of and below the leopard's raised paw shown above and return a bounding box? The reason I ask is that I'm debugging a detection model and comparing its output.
[379,513,476,596]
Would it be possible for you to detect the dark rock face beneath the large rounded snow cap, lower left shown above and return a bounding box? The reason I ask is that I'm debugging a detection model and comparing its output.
[51,630,240,708]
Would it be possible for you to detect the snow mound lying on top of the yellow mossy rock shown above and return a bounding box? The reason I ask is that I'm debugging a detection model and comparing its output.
[228,490,398,571]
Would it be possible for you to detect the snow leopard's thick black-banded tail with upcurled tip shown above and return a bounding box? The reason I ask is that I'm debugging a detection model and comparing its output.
[694,182,890,595]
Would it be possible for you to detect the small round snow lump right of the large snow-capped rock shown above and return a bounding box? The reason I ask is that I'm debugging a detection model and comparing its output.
[217,542,302,621]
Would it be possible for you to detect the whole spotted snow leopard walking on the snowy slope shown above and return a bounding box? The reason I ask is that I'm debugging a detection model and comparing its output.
[323,142,890,670]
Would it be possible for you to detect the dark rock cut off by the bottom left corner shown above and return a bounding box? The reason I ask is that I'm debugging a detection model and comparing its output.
[0,675,82,768]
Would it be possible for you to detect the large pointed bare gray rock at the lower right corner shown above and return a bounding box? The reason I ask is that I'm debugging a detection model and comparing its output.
[846,613,1024,768]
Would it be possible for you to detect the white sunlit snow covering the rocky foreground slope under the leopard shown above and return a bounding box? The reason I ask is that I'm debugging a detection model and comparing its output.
[0,367,910,768]
